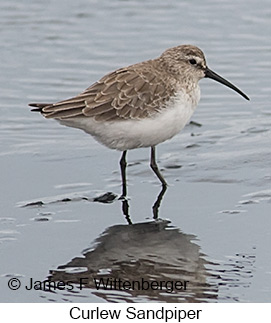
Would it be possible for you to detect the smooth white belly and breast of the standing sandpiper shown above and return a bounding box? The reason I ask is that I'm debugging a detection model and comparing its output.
[58,88,200,151]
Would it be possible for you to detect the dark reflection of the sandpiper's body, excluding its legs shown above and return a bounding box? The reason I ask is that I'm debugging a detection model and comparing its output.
[48,220,221,302]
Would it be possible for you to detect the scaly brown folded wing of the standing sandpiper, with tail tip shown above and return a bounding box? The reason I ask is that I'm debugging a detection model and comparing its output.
[32,61,176,121]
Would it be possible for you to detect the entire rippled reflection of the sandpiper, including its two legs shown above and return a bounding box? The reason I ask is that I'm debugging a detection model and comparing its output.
[43,188,255,302]
